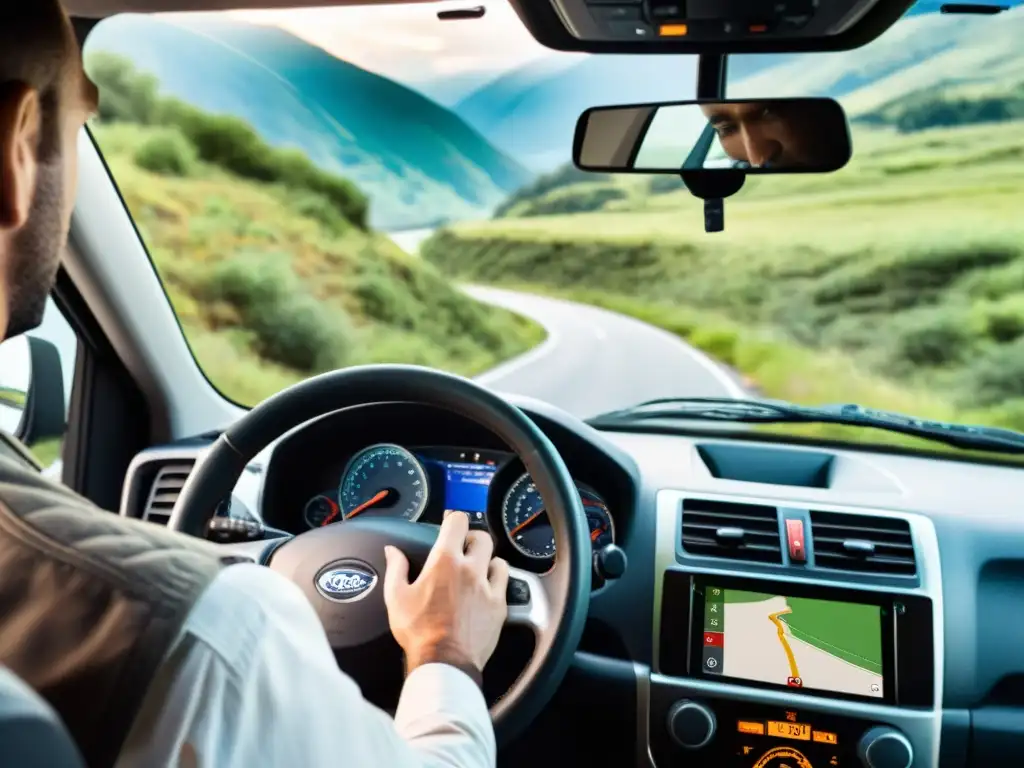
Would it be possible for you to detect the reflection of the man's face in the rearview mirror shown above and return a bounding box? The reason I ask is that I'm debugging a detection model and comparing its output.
[700,100,835,168]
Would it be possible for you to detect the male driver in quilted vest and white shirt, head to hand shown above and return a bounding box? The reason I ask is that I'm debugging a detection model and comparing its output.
[0,0,508,768]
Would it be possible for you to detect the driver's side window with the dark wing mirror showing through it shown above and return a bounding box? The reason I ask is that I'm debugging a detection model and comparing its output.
[0,299,78,479]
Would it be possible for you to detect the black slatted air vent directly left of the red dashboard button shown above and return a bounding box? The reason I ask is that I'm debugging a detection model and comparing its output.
[683,499,782,563]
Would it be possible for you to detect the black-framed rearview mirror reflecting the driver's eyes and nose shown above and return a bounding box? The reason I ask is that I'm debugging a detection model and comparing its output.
[572,98,851,174]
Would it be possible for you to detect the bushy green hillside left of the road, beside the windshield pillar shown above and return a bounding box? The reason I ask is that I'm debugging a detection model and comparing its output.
[91,116,543,404]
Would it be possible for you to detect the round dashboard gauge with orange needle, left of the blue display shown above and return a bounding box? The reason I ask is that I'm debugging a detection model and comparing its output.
[338,442,427,520]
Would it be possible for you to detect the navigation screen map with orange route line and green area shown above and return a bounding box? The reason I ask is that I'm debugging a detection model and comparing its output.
[703,586,884,697]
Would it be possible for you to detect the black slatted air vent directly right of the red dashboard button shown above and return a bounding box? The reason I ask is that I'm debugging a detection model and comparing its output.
[811,510,918,575]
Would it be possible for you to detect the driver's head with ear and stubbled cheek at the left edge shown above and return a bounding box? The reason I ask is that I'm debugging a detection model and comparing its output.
[0,0,96,340]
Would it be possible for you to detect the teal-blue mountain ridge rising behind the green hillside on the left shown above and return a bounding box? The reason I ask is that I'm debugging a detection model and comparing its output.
[86,15,531,230]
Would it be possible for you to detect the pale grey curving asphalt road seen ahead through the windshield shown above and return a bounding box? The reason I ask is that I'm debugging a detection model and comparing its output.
[464,286,746,419]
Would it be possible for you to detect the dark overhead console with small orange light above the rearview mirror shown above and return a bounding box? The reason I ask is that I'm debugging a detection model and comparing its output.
[513,0,910,53]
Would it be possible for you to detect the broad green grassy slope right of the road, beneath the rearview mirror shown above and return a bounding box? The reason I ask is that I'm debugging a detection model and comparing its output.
[423,124,1024,456]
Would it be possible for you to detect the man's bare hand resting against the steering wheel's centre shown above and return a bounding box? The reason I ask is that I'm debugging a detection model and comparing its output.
[384,512,509,672]
